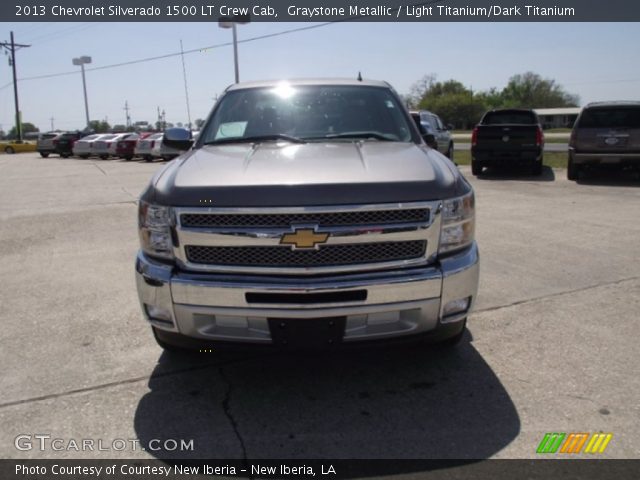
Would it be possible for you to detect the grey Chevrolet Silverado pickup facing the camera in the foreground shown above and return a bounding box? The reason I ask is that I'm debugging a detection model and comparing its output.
[136,79,479,349]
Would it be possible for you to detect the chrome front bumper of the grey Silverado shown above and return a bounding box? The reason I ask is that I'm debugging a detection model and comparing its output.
[136,243,479,344]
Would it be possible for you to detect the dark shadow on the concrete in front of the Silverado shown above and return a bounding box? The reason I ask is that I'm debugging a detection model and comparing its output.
[134,333,520,473]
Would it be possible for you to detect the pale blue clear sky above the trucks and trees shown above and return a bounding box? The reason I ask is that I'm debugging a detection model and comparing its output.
[0,22,640,131]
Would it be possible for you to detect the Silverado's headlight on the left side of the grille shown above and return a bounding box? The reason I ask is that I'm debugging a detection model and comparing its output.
[138,200,174,259]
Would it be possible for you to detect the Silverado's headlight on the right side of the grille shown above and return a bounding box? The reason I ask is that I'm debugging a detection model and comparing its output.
[438,191,475,253]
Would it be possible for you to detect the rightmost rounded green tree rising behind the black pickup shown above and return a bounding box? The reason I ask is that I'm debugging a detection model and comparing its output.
[501,72,579,108]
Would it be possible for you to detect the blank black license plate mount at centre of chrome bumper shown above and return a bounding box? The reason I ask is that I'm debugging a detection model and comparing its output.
[267,317,347,349]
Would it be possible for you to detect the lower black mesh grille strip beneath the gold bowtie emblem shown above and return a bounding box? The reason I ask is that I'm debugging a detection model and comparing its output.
[185,240,427,267]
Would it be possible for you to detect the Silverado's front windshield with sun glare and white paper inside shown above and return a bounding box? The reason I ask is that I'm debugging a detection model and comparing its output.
[200,84,412,144]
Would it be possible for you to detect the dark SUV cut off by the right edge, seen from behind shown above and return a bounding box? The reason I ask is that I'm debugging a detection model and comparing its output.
[567,102,640,180]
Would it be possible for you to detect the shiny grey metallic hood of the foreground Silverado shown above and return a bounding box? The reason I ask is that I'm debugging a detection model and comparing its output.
[148,141,468,207]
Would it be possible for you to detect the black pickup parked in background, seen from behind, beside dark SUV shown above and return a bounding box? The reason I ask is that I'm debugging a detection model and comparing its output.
[471,109,544,176]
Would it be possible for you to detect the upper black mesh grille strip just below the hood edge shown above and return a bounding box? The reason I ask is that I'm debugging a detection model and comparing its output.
[180,208,429,229]
